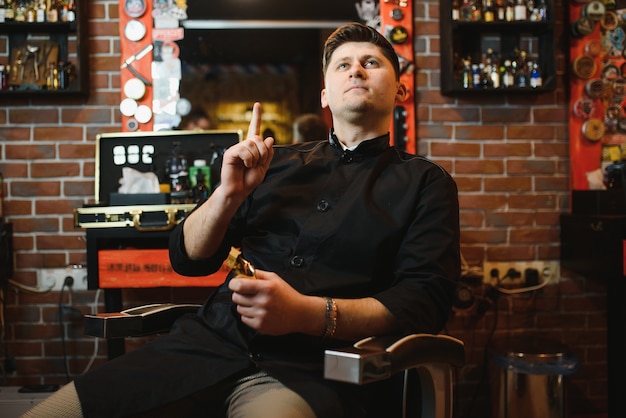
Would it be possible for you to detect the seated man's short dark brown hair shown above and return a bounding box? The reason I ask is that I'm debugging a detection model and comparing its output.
[322,22,400,79]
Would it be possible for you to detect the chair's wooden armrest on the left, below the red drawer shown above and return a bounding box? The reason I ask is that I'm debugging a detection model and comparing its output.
[84,303,201,338]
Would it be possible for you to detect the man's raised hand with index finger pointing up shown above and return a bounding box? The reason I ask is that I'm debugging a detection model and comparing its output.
[220,102,274,200]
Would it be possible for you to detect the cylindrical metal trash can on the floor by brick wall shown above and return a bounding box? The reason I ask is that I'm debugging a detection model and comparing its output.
[489,336,579,418]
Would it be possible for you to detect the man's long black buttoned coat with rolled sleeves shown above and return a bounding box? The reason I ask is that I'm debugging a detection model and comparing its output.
[77,135,460,418]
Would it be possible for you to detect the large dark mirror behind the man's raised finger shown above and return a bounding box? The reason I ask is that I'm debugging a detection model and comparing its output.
[179,0,378,143]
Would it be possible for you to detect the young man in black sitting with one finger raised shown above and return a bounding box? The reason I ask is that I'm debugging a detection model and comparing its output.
[23,23,460,418]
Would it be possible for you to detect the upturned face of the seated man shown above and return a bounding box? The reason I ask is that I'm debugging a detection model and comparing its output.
[321,42,405,121]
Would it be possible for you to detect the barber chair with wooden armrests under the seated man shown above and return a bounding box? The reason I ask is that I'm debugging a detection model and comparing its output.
[84,303,465,418]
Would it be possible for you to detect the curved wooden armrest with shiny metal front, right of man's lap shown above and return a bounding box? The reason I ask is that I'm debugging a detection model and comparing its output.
[324,334,465,384]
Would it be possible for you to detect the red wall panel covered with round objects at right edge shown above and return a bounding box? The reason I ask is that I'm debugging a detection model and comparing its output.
[569,0,626,190]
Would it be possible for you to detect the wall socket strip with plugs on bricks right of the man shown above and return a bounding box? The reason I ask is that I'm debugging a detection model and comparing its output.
[483,261,560,288]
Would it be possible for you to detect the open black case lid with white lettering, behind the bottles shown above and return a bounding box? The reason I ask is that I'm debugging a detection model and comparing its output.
[95,130,243,206]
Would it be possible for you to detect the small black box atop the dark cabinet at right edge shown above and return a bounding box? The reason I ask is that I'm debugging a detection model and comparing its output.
[572,189,626,215]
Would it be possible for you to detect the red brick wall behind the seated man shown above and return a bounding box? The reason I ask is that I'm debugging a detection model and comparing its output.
[0,0,607,417]
